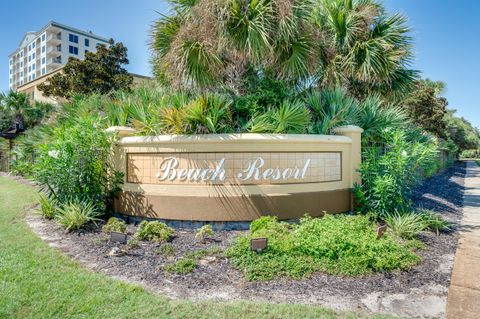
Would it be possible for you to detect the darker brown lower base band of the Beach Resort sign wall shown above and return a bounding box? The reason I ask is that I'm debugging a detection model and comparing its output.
[115,189,352,222]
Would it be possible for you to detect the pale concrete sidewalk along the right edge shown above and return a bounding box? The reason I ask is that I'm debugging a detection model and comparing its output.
[447,161,480,319]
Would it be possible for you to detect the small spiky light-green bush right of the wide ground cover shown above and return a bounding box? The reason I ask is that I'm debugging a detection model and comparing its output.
[385,212,426,239]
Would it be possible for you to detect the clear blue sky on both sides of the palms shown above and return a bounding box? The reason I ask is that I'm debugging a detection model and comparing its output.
[0,0,480,127]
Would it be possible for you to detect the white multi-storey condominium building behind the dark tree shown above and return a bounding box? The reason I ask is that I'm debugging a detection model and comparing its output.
[9,21,108,90]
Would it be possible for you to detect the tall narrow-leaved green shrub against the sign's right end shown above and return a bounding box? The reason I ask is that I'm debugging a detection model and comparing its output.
[354,130,437,218]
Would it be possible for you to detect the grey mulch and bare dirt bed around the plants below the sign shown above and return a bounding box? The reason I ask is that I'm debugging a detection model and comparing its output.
[27,162,465,318]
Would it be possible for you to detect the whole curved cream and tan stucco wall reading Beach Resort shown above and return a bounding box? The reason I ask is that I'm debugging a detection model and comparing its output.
[111,126,362,222]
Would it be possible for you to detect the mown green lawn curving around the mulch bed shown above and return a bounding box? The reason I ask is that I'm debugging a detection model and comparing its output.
[0,177,394,319]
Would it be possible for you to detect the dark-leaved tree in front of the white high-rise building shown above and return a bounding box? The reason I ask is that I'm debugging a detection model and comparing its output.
[38,39,133,98]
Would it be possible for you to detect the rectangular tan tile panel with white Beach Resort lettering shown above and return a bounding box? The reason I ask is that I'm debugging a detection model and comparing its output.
[126,152,342,185]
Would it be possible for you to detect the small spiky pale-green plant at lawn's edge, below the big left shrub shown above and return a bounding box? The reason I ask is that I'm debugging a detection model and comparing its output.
[55,200,100,231]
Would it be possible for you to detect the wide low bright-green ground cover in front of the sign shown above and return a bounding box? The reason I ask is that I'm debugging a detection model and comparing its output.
[226,215,420,280]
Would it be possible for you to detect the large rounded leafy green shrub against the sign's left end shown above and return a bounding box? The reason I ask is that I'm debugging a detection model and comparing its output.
[34,116,123,212]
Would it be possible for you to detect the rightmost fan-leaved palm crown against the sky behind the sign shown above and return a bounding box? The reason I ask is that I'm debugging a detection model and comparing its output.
[313,0,417,98]
